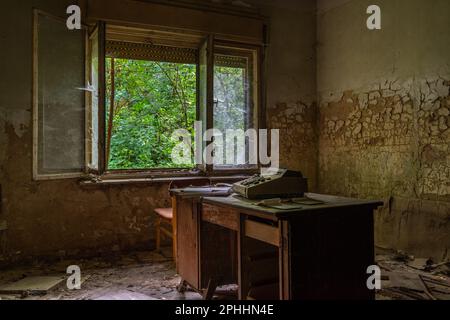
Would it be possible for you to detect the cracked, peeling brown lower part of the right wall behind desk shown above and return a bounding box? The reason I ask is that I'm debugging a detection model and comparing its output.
[319,77,450,260]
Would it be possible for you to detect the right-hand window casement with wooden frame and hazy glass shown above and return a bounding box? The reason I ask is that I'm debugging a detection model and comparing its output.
[196,36,260,173]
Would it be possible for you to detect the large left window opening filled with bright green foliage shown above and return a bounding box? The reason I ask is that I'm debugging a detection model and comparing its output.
[106,58,196,170]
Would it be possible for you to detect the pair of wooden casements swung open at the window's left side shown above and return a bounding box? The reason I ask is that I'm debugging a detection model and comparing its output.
[33,10,105,180]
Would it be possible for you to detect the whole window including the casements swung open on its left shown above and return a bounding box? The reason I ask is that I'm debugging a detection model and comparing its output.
[33,10,261,179]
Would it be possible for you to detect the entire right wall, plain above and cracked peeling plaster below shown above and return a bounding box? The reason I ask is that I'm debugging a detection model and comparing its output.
[317,0,450,261]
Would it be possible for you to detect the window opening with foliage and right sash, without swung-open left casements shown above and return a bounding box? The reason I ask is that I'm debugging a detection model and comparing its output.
[96,26,259,172]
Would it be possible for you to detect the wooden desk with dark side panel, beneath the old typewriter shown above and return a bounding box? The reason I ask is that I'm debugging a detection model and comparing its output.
[200,194,383,299]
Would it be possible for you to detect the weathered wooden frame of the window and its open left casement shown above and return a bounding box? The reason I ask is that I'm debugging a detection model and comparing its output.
[32,1,268,180]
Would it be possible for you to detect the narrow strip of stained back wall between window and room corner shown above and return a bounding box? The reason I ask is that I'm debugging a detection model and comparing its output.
[249,0,318,191]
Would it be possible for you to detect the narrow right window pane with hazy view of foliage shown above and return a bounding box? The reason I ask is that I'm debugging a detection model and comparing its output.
[214,52,257,168]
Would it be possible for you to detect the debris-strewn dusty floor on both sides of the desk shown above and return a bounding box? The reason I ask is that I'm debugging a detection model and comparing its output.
[0,248,450,300]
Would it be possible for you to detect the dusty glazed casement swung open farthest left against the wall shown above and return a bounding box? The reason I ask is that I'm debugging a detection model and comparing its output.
[33,10,86,180]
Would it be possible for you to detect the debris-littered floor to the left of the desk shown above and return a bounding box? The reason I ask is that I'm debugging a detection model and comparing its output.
[0,252,201,300]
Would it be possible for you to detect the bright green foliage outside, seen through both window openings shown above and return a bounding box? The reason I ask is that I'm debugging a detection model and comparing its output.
[106,58,248,170]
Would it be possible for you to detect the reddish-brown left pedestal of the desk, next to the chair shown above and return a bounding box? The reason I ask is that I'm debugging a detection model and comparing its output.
[170,187,232,298]
